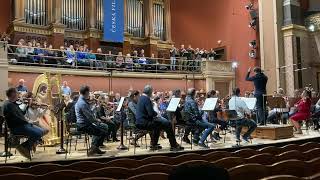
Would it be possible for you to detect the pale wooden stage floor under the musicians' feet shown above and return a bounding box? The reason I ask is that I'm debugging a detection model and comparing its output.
[0,126,320,164]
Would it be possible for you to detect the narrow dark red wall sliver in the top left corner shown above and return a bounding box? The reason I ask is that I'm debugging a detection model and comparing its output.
[0,0,13,33]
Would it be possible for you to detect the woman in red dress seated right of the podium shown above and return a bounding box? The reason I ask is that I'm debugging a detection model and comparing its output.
[290,90,311,134]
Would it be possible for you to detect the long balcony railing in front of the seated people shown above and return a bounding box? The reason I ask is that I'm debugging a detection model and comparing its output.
[8,45,210,74]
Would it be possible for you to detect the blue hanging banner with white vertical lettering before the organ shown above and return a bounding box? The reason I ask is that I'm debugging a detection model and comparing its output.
[103,0,124,43]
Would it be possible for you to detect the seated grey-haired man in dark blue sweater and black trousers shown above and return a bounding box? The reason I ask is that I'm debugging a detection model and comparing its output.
[136,85,183,151]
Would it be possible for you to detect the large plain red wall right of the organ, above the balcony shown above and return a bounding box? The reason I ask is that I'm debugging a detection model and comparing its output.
[171,0,259,91]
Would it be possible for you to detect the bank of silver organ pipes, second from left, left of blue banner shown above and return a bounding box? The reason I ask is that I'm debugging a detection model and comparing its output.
[61,0,86,30]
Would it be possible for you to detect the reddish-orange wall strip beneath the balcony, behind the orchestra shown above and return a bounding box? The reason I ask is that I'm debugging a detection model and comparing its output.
[9,72,205,95]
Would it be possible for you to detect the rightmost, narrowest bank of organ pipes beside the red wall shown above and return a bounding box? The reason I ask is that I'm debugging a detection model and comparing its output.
[153,0,165,40]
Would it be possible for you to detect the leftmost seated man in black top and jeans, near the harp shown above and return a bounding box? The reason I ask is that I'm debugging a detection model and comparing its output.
[3,88,45,159]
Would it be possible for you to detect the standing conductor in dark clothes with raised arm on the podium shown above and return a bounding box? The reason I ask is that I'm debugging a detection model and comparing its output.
[246,67,268,125]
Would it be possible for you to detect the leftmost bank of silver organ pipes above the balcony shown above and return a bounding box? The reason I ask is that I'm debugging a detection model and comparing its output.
[24,0,48,26]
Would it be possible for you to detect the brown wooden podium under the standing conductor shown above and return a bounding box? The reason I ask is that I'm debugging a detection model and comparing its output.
[243,125,293,140]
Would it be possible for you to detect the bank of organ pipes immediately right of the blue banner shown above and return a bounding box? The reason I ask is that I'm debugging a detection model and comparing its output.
[126,0,144,37]
